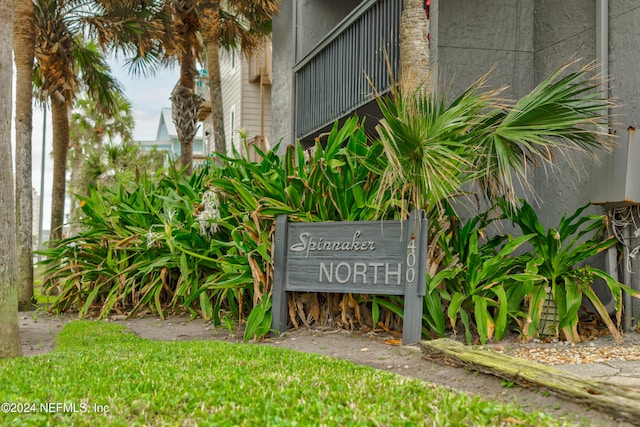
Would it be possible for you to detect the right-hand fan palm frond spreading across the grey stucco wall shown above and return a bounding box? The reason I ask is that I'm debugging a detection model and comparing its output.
[474,60,612,207]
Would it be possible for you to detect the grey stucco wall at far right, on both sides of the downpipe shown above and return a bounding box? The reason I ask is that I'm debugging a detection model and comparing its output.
[535,0,640,224]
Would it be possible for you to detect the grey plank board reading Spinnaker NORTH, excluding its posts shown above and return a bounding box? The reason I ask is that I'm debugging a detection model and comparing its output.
[285,221,406,295]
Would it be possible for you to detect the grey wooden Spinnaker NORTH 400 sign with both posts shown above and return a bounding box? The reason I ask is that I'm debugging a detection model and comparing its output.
[272,210,427,345]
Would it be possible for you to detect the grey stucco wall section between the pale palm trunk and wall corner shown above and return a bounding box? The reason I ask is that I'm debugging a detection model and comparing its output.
[436,0,534,97]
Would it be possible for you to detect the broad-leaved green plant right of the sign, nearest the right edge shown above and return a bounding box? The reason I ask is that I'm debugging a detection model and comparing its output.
[504,201,638,343]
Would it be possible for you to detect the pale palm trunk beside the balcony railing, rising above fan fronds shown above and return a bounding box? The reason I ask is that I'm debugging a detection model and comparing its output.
[400,0,429,93]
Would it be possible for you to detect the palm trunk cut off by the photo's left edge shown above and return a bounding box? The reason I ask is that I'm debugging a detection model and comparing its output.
[0,0,22,359]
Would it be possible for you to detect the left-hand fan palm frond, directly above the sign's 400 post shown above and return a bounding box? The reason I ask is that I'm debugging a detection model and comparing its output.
[377,76,499,216]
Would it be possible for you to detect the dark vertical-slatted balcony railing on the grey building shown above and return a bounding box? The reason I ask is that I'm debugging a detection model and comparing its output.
[294,0,402,139]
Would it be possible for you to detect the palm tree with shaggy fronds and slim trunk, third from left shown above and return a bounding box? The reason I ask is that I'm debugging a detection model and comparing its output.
[34,0,172,240]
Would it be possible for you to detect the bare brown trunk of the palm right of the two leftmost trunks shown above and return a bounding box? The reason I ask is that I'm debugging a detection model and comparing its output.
[50,96,69,241]
